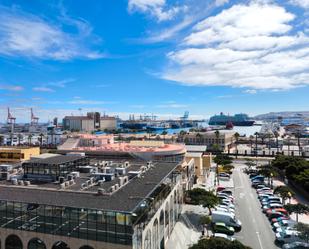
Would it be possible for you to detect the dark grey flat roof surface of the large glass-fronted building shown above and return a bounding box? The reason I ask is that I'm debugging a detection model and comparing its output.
[0,161,178,213]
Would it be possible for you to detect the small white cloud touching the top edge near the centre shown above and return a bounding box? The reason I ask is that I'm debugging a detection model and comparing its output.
[128,0,186,21]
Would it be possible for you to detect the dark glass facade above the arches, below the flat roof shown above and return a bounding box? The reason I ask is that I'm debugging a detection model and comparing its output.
[0,201,133,245]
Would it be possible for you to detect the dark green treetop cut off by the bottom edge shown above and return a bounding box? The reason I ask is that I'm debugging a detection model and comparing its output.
[189,237,251,249]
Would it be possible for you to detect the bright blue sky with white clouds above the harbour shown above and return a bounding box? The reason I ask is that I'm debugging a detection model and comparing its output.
[0,0,309,122]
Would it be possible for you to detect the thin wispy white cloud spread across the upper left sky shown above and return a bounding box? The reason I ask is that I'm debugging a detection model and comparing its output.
[0,7,104,60]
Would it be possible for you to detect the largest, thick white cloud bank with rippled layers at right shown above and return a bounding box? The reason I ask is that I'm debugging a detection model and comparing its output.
[163,3,309,89]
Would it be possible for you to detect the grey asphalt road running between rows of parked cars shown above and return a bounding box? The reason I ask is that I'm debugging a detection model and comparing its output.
[233,164,279,249]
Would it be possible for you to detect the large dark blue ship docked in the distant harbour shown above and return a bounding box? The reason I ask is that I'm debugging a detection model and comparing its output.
[208,112,254,126]
